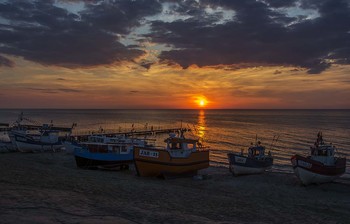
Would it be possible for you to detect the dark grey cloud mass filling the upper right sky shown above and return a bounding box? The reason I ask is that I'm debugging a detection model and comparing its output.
[148,0,350,73]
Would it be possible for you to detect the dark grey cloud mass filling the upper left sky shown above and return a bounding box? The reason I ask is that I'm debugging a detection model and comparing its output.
[0,0,161,67]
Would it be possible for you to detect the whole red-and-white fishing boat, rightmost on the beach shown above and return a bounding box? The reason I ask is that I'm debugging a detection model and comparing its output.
[291,132,346,185]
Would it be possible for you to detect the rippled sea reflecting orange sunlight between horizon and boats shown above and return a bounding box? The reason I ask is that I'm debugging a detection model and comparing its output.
[0,109,350,176]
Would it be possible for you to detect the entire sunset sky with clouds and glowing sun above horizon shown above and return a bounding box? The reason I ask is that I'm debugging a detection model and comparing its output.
[0,0,350,109]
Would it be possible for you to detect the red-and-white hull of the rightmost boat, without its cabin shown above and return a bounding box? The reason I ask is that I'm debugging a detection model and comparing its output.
[291,155,346,185]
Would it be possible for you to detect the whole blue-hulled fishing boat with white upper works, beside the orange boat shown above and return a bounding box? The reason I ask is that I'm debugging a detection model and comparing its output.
[64,135,148,169]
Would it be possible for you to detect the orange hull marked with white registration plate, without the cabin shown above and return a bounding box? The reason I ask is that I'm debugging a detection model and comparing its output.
[134,147,209,177]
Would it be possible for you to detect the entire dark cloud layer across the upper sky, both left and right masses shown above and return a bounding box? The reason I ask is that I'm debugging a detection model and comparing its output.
[0,0,350,74]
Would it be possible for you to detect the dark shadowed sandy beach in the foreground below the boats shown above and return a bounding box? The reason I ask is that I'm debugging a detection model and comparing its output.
[0,152,350,223]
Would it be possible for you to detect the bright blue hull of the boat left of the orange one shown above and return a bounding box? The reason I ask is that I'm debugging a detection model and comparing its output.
[74,146,133,169]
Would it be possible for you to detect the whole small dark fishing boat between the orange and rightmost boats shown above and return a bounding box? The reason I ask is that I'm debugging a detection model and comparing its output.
[227,141,273,176]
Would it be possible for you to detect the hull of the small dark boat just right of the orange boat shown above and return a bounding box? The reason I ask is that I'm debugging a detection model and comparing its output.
[227,153,273,176]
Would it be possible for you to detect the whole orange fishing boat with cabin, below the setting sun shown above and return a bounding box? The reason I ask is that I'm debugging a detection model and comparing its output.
[134,133,209,177]
